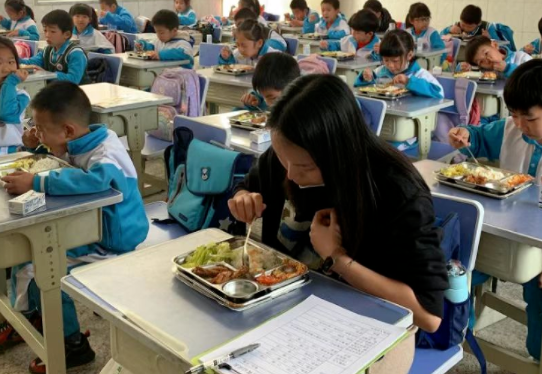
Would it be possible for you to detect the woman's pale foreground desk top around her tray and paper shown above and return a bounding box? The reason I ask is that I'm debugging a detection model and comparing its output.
[62,229,412,357]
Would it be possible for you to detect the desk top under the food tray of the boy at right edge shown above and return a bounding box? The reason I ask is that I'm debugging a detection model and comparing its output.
[414,160,542,248]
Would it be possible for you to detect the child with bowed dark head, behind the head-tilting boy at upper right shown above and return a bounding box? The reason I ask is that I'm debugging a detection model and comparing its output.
[440,5,500,40]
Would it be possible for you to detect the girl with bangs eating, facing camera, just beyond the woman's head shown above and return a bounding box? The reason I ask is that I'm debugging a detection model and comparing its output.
[360,30,444,99]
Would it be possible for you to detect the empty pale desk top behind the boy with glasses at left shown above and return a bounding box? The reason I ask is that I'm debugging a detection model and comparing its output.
[81,83,173,113]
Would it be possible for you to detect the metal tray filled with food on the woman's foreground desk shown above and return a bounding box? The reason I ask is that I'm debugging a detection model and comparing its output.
[173,237,309,306]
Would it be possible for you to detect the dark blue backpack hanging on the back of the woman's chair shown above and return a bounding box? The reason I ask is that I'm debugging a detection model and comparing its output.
[416,213,487,374]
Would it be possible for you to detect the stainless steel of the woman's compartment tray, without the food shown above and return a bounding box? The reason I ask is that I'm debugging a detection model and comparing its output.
[173,237,309,309]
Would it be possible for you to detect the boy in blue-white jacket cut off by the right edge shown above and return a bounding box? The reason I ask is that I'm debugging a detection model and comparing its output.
[449,60,542,360]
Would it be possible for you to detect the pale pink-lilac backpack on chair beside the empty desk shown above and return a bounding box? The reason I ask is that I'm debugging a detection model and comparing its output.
[148,68,204,142]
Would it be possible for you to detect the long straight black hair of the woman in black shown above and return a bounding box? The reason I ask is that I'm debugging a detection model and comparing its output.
[267,74,427,256]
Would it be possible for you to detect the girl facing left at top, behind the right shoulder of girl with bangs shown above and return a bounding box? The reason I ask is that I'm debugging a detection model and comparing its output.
[406,3,447,61]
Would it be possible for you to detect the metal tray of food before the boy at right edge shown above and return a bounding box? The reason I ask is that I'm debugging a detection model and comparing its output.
[435,162,534,198]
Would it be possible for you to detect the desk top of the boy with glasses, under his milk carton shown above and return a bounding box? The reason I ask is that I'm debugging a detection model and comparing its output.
[0,153,122,232]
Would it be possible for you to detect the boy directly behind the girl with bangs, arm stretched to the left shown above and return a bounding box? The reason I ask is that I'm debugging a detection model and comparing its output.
[320,10,380,57]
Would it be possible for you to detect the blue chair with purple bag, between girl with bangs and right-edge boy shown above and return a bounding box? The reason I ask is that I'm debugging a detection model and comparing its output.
[403,77,478,163]
